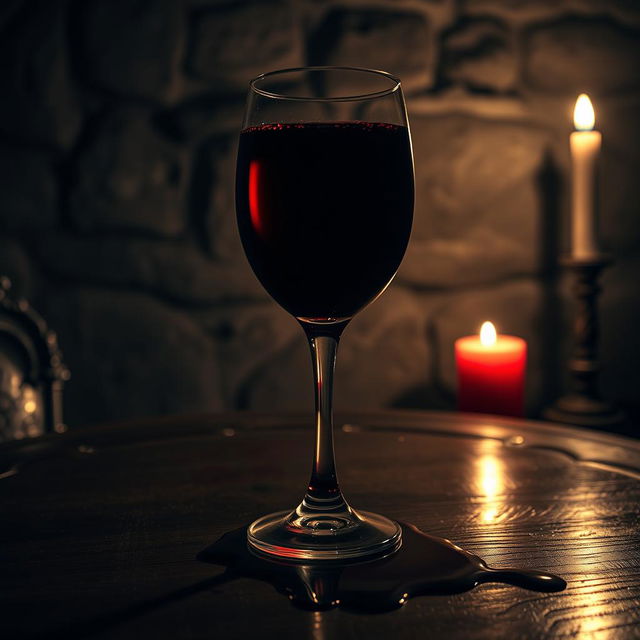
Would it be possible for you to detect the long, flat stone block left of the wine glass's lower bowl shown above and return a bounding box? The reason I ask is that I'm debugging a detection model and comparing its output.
[36,234,267,305]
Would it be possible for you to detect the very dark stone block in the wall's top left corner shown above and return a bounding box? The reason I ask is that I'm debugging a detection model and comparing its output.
[0,0,82,147]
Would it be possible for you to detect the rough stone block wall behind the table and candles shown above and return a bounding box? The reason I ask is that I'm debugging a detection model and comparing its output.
[0,0,640,425]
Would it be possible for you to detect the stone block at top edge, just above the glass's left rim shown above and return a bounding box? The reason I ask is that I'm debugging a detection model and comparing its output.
[186,0,303,92]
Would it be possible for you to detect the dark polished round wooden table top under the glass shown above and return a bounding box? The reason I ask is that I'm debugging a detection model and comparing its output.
[0,411,640,640]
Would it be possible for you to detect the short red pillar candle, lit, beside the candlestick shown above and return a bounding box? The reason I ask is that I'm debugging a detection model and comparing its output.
[455,322,527,416]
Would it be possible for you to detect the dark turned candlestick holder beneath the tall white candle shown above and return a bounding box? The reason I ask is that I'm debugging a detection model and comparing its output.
[544,254,625,429]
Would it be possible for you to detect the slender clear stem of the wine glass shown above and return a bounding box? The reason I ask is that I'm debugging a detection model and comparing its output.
[303,323,348,512]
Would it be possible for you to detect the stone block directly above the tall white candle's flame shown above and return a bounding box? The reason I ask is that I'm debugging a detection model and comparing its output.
[524,17,640,95]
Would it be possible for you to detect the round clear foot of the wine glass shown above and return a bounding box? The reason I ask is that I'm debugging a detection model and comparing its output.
[247,509,402,561]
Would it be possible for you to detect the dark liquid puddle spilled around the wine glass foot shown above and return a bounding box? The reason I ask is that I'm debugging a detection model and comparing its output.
[198,523,566,613]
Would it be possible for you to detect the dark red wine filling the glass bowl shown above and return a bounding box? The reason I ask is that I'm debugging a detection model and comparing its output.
[236,122,413,321]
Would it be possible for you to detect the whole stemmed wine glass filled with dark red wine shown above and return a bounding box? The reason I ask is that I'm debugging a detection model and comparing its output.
[236,67,414,562]
